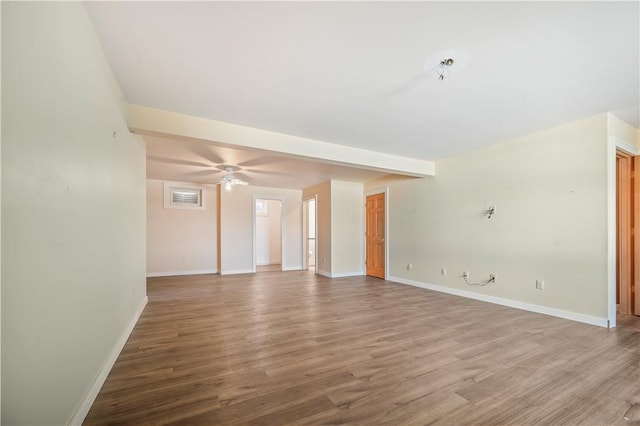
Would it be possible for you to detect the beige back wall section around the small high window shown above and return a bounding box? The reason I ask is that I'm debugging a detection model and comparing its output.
[147,179,218,276]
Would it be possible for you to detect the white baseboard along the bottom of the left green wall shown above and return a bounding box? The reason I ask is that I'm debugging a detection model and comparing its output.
[67,296,149,425]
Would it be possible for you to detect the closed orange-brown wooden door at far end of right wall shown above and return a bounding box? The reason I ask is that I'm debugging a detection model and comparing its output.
[365,193,385,279]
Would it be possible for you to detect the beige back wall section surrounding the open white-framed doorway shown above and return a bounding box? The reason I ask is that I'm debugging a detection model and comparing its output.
[219,186,302,274]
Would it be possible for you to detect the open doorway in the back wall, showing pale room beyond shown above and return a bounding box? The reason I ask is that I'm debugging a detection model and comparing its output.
[253,198,282,272]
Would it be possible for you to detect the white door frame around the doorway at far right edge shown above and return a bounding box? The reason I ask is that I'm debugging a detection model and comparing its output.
[607,136,640,328]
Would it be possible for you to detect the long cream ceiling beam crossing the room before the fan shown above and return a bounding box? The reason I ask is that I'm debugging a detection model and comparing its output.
[128,105,435,177]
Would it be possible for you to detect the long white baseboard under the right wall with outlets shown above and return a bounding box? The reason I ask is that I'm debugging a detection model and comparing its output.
[388,276,608,327]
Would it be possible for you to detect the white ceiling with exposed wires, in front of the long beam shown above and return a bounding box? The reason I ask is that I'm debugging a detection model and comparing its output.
[87,2,640,186]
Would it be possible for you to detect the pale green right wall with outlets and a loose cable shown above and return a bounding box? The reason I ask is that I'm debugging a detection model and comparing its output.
[367,114,608,319]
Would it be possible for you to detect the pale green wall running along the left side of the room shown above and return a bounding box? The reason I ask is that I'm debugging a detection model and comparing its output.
[2,2,146,425]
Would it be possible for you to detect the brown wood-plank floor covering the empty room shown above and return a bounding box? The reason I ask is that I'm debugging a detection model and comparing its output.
[84,272,640,426]
